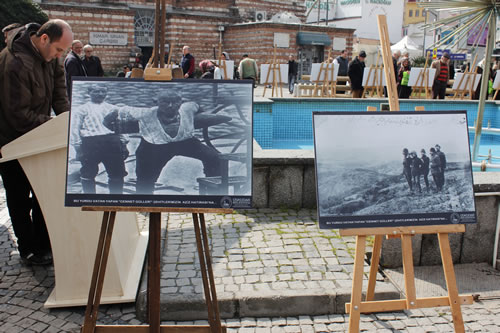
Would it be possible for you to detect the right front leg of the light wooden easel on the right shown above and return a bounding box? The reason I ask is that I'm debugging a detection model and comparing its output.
[438,233,465,332]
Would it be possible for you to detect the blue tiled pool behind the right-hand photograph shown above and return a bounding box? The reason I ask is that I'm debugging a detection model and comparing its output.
[254,98,500,160]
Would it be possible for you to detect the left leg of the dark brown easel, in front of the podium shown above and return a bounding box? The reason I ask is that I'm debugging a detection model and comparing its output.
[82,212,116,333]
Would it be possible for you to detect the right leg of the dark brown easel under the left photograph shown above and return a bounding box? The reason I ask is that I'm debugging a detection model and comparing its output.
[193,213,222,333]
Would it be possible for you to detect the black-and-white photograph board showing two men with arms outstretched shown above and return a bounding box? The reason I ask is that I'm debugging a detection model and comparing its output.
[65,78,253,208]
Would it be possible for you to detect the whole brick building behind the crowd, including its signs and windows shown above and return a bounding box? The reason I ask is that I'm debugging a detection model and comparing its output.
[37,0,354,73]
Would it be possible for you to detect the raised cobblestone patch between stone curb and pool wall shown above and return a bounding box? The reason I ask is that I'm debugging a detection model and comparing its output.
[162,209,376,298]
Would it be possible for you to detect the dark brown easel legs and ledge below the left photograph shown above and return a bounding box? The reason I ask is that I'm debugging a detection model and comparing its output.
[81,207,232,333]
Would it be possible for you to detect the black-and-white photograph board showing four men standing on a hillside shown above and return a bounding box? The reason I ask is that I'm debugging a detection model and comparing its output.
[313,111,476,228]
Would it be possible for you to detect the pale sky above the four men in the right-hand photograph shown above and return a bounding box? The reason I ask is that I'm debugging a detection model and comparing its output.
[314,112,469,163]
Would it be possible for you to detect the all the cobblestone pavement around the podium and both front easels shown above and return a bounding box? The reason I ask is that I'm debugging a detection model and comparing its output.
[0,187,500,333]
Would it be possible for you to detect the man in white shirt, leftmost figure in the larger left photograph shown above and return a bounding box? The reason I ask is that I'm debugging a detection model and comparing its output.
[70,84,128,194]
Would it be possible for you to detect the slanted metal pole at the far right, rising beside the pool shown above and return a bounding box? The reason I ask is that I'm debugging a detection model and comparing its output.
[472,11,497,161]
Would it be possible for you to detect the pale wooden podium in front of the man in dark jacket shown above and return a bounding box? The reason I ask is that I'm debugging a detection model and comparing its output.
[0,112,148,308]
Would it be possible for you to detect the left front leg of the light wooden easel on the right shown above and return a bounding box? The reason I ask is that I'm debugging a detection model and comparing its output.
[349,236,366,333]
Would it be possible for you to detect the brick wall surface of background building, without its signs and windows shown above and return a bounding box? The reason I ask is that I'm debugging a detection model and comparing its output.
[40,0,353,71]
